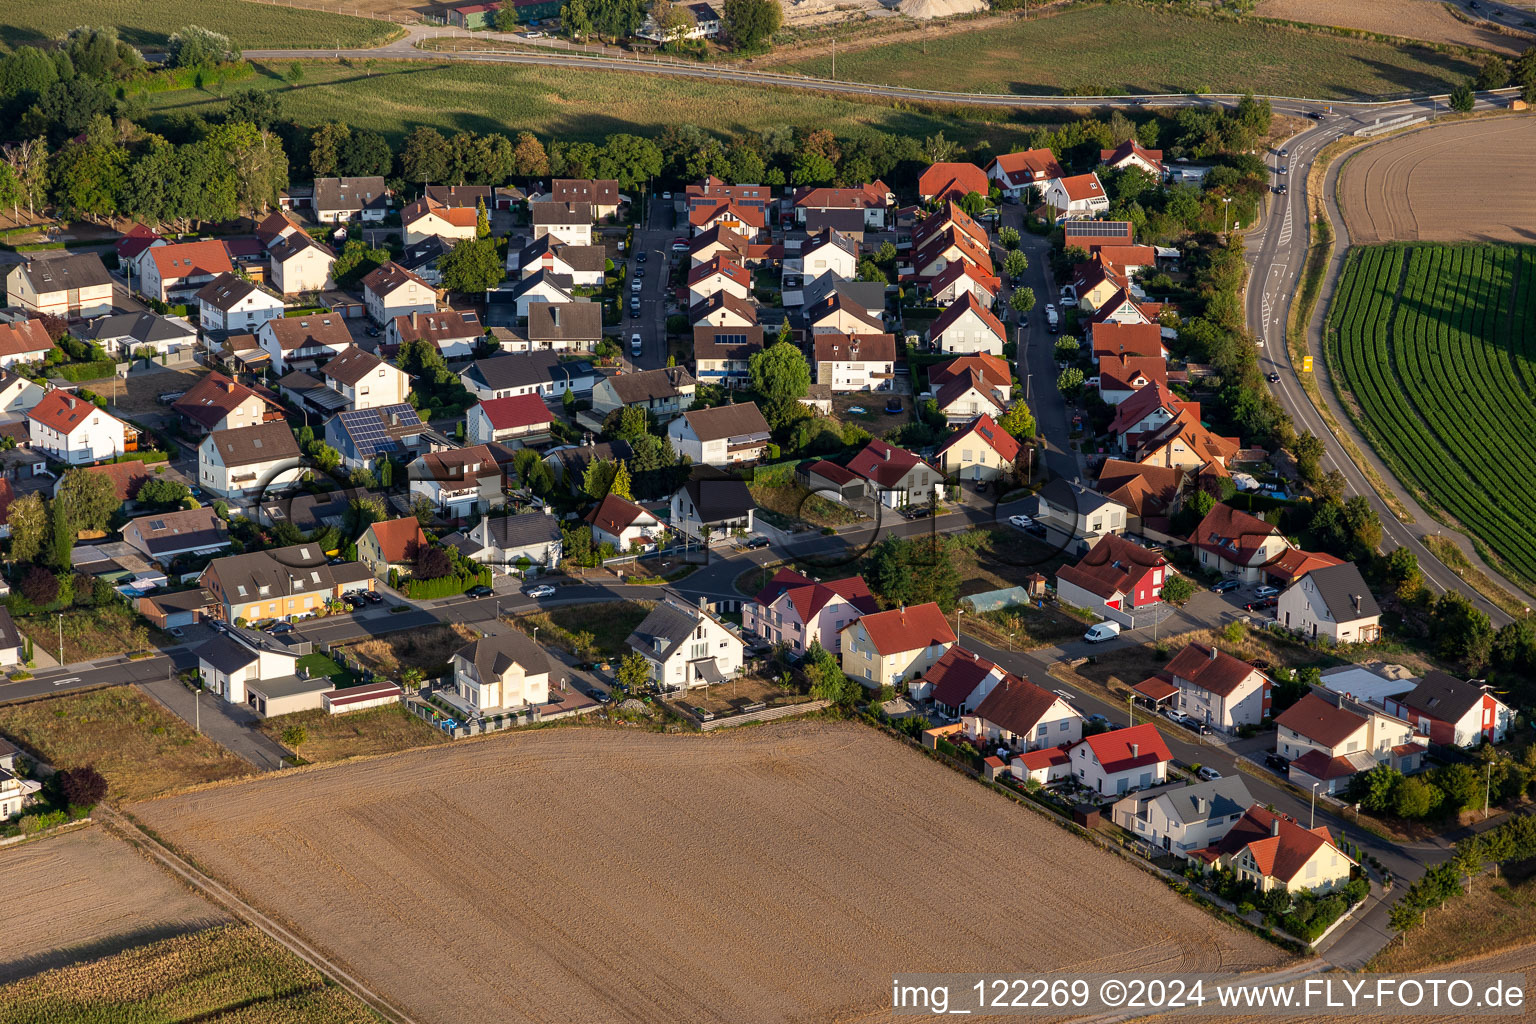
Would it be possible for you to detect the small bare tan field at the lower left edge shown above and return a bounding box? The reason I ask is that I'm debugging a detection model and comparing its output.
[0,826,229,982]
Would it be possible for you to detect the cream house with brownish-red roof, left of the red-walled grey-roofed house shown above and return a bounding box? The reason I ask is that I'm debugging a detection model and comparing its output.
[1275,689,1428,794]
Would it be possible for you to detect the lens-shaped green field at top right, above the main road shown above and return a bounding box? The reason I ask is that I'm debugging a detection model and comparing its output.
[785,3,1476,100]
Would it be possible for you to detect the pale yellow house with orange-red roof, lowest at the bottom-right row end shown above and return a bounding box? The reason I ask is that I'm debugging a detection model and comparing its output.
[1203,803,1355,892]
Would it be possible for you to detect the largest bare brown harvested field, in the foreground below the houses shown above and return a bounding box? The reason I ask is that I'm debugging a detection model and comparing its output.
[134,722,1284,1022]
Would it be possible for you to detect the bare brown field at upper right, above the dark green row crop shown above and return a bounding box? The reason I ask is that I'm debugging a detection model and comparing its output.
[1338,115,1536,244]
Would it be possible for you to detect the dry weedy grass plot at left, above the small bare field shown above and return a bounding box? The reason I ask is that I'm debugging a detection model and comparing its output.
[0,686,250,804]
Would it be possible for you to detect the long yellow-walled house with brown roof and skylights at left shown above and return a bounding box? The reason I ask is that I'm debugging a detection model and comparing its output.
[198,542,373,625]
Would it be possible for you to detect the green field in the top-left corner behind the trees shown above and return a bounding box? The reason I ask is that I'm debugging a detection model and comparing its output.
[0,0,401,51]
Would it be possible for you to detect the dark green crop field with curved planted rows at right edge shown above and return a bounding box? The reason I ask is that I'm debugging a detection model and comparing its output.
[1327,244,1536,580]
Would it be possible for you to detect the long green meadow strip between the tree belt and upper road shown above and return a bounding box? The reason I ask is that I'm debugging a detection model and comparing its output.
[147,60,1028,152]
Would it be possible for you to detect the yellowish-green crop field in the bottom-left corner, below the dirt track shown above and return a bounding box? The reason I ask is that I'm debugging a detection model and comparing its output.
[0,926,379,1024]
